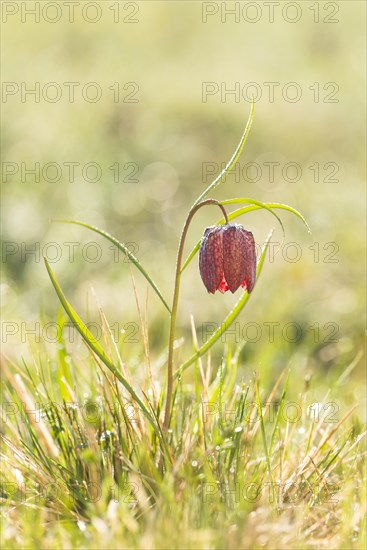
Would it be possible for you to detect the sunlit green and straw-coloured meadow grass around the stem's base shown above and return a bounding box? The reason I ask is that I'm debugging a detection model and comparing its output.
[2,313,366,549]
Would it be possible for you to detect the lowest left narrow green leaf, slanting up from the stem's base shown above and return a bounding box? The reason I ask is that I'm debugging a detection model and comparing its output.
[44,258,160,435]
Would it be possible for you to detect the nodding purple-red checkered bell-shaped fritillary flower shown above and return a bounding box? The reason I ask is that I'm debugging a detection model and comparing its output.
[199,224,256,294]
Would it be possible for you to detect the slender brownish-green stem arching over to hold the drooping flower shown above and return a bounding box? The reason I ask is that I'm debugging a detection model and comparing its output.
[163,199,228,432]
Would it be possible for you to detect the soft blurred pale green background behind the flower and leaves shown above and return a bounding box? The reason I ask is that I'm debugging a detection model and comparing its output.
[1,1,366,406]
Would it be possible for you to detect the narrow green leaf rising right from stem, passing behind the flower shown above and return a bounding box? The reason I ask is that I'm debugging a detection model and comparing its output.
[174,231,273,378]
